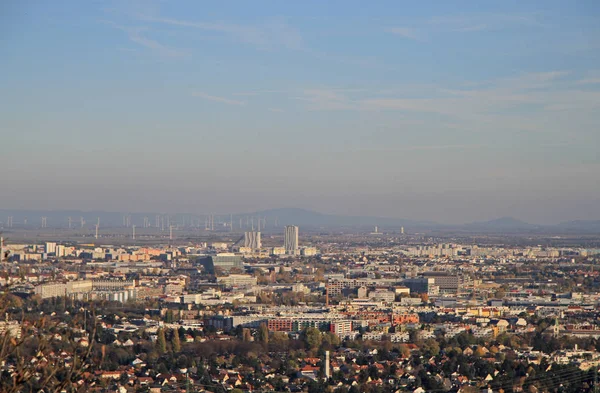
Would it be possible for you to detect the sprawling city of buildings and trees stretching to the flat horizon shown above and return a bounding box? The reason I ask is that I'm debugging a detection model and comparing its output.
[0,210,600,392]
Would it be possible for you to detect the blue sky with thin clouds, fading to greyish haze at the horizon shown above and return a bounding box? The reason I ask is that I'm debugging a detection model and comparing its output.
[0,0,600,224]
